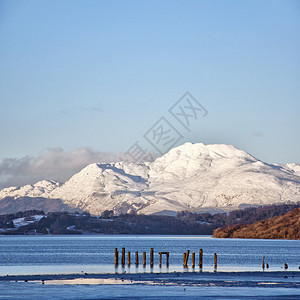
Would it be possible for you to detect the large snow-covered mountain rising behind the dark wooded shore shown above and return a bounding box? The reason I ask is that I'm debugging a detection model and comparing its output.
[0,143,300,215]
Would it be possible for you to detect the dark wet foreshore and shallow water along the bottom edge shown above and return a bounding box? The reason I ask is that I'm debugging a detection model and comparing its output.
[0,271,300,300]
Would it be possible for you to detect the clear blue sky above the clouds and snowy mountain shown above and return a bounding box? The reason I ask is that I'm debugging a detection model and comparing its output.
[0,0,300,188]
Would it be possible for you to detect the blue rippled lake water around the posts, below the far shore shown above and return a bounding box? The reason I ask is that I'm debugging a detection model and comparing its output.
[0,235,300,276]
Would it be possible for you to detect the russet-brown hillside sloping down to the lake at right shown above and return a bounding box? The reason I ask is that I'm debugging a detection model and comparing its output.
[213,208,300,240]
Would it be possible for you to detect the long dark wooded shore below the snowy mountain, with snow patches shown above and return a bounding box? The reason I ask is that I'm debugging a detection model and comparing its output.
[0,203,300,235]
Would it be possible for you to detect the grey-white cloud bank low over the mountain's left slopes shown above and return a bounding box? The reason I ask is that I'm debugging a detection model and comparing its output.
[0,148,121,189]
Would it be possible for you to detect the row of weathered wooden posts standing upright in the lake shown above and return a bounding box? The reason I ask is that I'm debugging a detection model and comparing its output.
[115,248,218,269]
